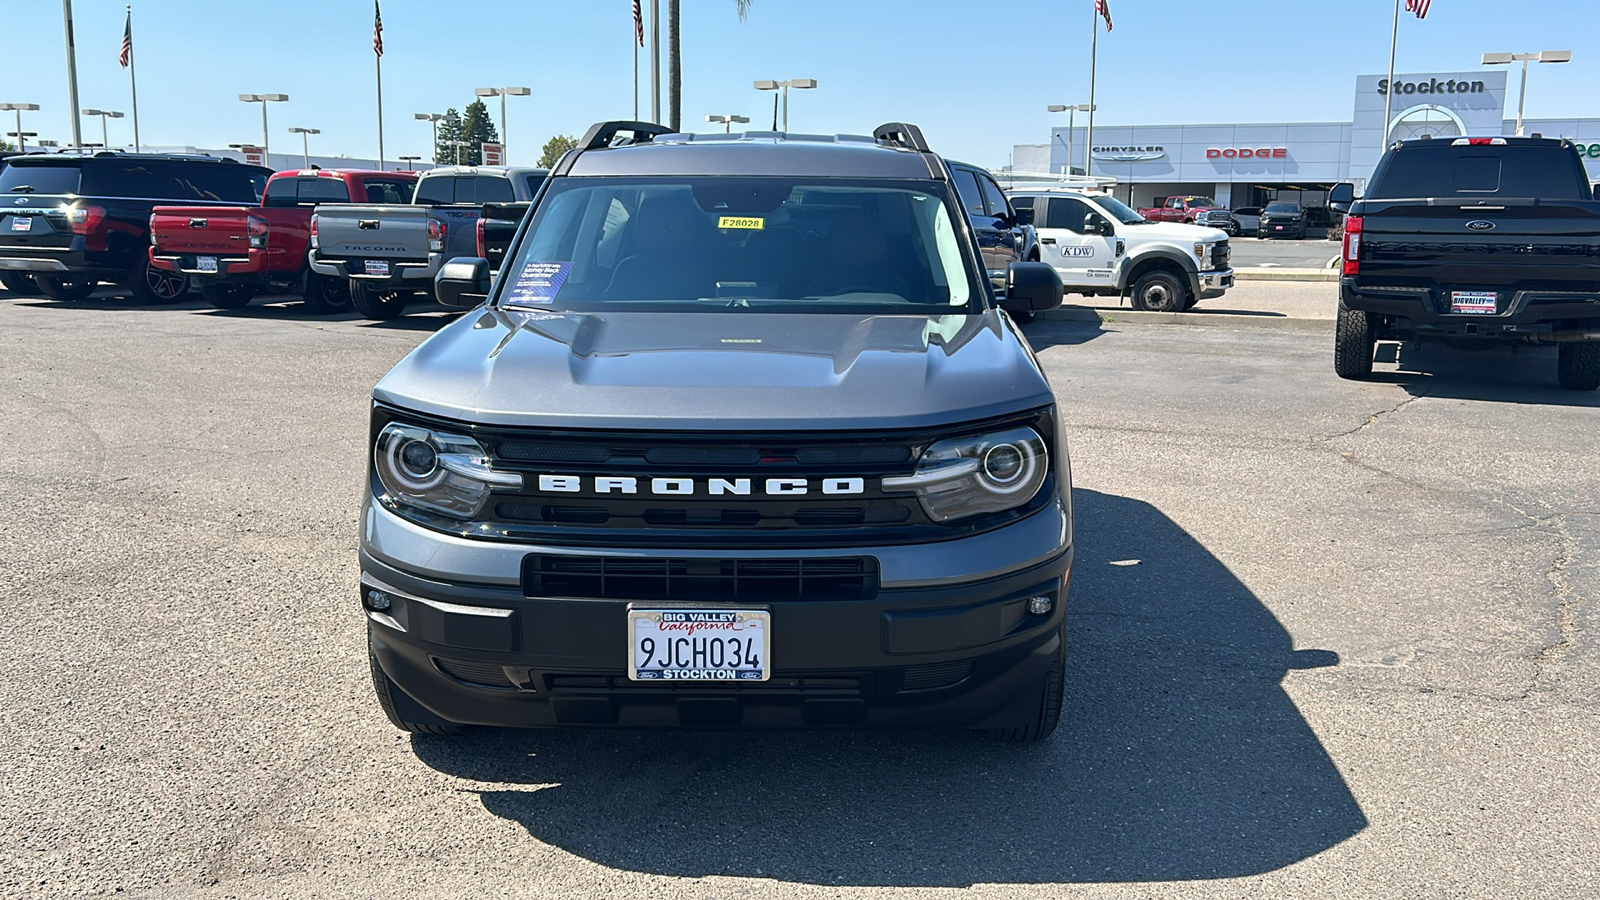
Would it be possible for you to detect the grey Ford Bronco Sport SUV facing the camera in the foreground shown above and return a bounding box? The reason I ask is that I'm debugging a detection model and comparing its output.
[360,122,1072,740]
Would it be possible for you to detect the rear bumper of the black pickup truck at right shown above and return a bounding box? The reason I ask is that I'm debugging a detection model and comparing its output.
[1339,277,1600,334]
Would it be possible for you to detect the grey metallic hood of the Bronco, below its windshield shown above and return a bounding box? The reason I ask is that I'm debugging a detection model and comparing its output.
[373,307,1054,431]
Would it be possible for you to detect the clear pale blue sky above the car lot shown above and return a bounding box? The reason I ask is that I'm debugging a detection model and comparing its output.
[0,0,1600,165]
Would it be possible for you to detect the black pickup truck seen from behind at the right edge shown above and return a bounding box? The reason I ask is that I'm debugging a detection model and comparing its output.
[1330,136,1600,391]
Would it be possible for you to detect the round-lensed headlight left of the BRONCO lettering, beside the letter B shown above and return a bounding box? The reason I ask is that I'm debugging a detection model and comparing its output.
[373,423,522,519]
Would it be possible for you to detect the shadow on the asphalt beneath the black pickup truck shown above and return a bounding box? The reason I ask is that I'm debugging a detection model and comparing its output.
[1373,343,1600,407]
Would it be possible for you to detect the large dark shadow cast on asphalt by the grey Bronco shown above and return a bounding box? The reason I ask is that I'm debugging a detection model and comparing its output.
[413,490,1366,887]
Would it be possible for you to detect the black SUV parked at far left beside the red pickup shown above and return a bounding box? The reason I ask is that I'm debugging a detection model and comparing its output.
[0,152,272,303]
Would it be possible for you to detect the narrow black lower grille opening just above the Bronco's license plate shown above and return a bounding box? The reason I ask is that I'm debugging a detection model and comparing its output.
[522,554,878,602]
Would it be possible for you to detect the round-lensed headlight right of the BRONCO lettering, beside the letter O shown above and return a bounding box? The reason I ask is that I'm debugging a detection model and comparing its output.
[883,428,1050,522]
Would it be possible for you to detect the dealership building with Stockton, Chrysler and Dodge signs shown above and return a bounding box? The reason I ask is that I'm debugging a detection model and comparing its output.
[1011,69,1600,208]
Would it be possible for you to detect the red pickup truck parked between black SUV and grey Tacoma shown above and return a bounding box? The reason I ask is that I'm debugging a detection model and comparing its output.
[150,168,416,312]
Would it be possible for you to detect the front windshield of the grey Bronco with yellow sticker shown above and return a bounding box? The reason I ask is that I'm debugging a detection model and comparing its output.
[499,178,981,314]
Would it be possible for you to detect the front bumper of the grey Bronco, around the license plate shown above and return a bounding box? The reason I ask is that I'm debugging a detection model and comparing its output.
[362,496,1072,729]
